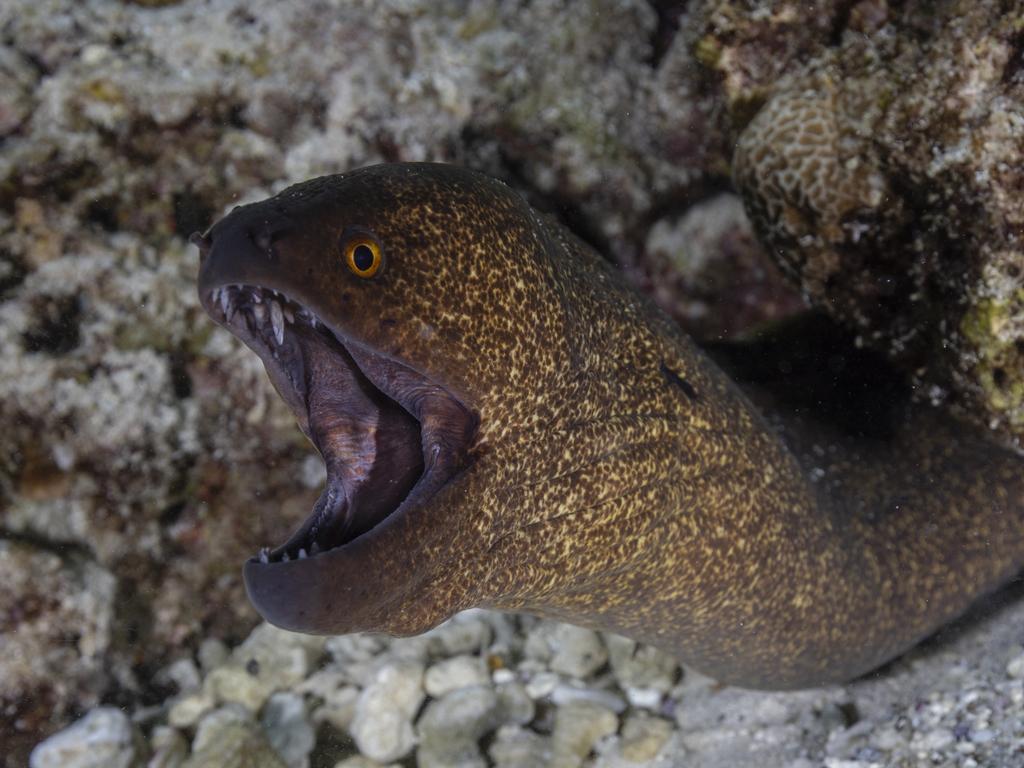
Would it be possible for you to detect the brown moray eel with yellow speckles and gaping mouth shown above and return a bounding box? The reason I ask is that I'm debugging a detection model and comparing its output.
[194,164,1024,688]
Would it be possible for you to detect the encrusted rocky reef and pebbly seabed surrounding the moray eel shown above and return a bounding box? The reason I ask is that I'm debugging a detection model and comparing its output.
[0,0,1024,768]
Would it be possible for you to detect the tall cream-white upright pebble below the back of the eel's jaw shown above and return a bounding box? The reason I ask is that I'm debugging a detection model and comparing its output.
[349,660,425,763]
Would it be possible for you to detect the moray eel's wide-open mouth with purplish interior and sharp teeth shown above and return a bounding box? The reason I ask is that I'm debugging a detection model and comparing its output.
[203,285,476,565]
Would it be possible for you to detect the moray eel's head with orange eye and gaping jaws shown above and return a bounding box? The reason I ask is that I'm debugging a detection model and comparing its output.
[193,164,573,634]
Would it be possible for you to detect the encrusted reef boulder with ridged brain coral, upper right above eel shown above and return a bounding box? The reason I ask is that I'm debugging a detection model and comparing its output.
[734,0,1024,441]
